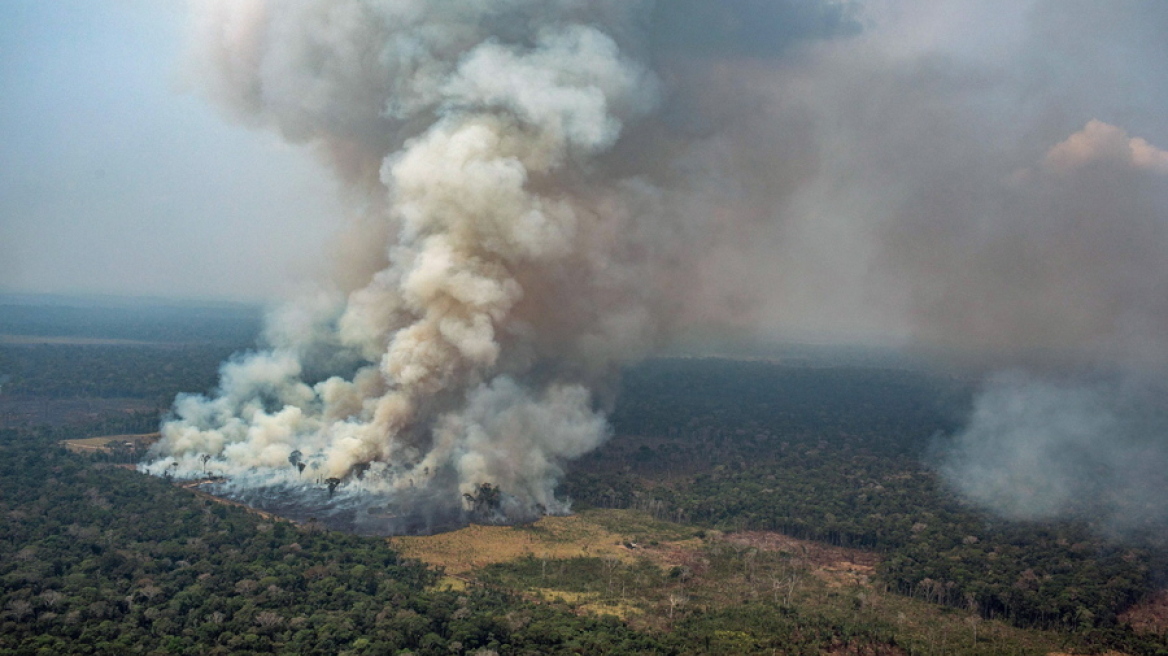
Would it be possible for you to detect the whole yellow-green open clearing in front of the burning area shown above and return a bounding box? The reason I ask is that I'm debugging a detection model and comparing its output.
[391,510,1121,656]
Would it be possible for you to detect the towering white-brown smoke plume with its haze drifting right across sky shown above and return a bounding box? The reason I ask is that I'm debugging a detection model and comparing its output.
[145,0,1168,531]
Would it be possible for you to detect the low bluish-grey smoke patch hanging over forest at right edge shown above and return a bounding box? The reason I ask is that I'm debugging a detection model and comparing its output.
[941,372,1168,535]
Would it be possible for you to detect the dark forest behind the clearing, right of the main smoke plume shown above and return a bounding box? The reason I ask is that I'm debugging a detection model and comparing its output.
[563,361,1163,652]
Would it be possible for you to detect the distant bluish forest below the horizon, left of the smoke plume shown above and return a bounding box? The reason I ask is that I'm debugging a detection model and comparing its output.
[0,298,260,424]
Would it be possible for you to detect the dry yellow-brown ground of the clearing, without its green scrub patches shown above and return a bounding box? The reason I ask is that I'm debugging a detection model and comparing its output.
[391,510,1111,656]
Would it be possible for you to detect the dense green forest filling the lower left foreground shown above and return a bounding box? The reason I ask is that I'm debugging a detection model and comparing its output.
[0,431,673,656]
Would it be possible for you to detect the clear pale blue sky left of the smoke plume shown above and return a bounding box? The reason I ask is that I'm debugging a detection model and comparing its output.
[0,0,339,299]
